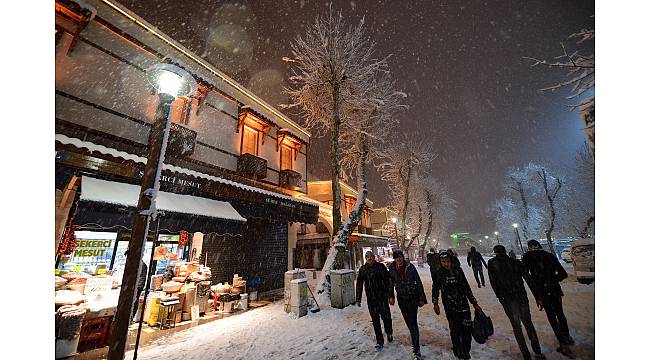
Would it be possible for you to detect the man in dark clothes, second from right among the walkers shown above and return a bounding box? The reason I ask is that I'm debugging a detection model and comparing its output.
[487,245,545,360]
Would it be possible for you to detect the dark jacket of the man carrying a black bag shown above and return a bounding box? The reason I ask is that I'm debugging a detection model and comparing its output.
[432,266,477,313]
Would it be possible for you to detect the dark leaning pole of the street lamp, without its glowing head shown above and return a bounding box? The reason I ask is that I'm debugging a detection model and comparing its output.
[108,93,174,360]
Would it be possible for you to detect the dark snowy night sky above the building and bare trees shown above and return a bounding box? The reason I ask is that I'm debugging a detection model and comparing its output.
[121,0,594,234]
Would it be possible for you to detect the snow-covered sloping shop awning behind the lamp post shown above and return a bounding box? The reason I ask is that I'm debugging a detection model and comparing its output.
[79,176,246,222]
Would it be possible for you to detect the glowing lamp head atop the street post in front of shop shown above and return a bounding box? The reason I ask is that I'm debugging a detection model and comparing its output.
[147,64,196,97]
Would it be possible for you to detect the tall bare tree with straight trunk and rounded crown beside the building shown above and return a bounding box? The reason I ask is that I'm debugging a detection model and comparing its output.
[283,8,386,234]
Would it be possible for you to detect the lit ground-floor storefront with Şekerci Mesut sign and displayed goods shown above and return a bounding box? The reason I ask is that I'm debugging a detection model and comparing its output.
[55,144,318,353]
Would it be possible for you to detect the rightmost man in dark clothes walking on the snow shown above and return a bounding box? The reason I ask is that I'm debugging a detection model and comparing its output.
[522,240,575,358]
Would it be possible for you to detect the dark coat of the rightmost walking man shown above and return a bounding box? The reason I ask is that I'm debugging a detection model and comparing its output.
[522,250,568,299]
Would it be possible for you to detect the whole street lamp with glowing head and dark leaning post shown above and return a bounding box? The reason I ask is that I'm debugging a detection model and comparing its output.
[108,64,196,360]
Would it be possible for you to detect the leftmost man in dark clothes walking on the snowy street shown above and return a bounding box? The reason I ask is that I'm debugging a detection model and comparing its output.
[357,251,395,350]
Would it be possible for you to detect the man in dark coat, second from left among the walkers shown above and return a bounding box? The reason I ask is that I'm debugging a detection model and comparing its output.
[388,250,427,359]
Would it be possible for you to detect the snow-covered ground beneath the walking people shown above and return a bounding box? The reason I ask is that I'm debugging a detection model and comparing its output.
[127,257,594,360]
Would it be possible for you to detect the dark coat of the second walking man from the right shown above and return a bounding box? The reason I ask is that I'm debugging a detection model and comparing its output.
[487,254,532,304]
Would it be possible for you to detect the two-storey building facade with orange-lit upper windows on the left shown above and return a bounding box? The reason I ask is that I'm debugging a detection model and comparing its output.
[55,0,318,291]
